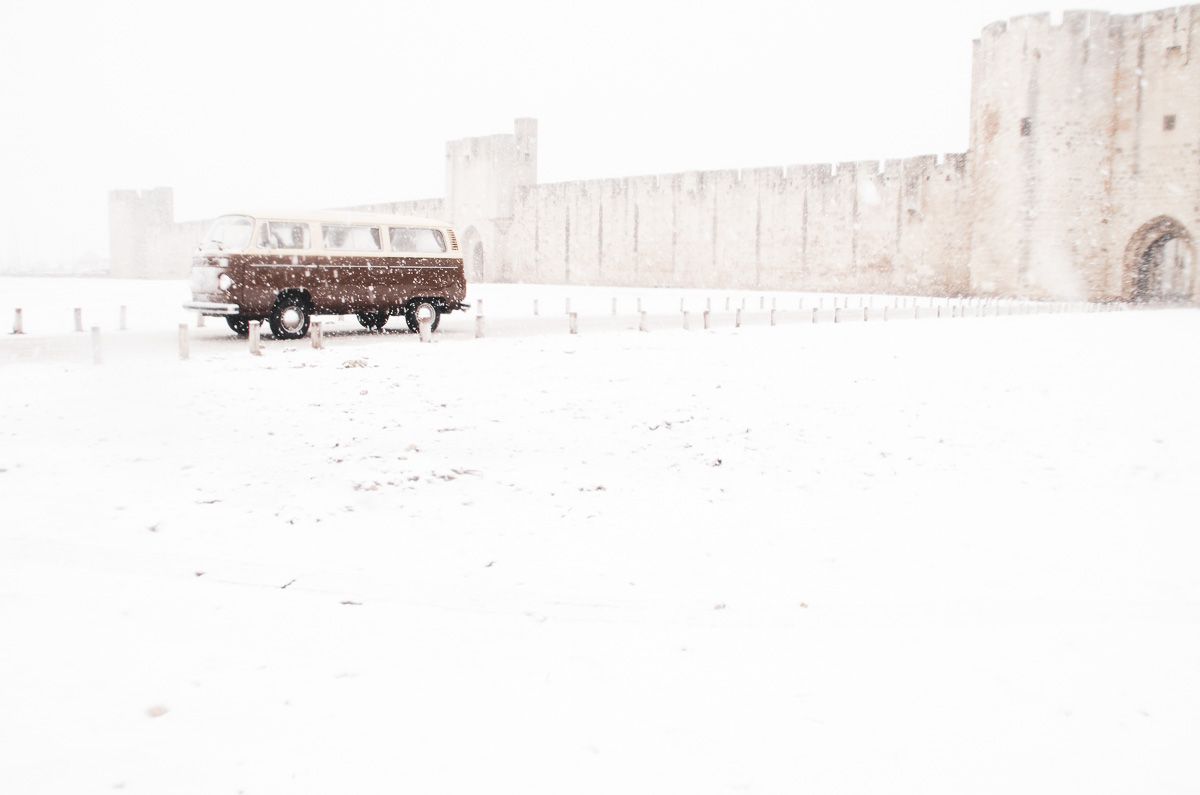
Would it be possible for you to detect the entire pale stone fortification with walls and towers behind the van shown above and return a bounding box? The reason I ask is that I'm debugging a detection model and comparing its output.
[109,6,1200,299]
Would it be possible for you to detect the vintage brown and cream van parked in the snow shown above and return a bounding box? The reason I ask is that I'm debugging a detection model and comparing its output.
[184,211,467,339]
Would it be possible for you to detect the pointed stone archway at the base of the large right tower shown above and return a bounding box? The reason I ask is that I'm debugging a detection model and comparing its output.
[1123,215,1196,303]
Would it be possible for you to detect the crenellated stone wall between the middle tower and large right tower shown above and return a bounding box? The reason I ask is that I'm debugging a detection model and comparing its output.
[505,155,970,293]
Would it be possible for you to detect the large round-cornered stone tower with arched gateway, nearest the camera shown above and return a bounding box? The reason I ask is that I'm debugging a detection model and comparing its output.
[971,6,1200,300]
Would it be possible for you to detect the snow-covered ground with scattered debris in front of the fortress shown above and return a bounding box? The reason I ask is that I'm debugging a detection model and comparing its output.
[0,280,1200,795]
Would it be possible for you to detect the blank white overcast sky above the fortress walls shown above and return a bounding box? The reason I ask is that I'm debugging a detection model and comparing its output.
[0,0,1160,267]
